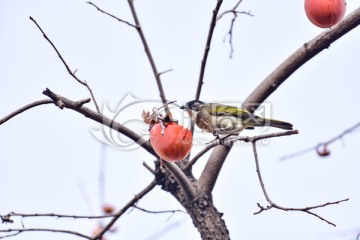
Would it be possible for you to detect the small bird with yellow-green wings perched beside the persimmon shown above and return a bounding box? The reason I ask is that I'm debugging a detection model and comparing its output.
[180,100,293,136]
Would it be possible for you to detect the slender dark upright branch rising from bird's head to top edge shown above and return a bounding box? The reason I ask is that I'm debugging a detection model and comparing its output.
[195,0,223,100]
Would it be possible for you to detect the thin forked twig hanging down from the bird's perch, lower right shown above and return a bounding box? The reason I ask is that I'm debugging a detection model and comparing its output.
[251,140,349,227]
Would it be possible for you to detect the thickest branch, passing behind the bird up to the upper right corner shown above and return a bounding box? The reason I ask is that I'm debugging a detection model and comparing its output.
[201,8,360,195]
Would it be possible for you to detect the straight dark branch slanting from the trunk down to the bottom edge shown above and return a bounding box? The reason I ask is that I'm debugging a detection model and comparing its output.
[89,180,156,240]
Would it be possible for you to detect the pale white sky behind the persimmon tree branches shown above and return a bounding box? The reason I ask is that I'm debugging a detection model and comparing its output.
[0,0,360,240]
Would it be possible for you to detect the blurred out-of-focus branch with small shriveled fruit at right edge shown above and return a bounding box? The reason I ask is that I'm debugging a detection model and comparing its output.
[280,122,360,160]
